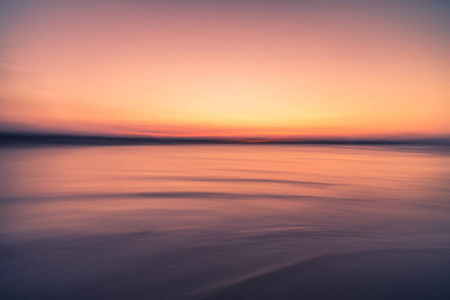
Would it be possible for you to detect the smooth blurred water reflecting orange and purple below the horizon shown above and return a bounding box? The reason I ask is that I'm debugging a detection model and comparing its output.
[0,145,450,300]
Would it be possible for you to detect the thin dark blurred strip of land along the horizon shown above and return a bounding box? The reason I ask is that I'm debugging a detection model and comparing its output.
[0,132,450,146]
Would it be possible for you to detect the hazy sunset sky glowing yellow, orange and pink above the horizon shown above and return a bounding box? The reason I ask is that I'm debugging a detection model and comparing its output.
[0,0,450,137]
